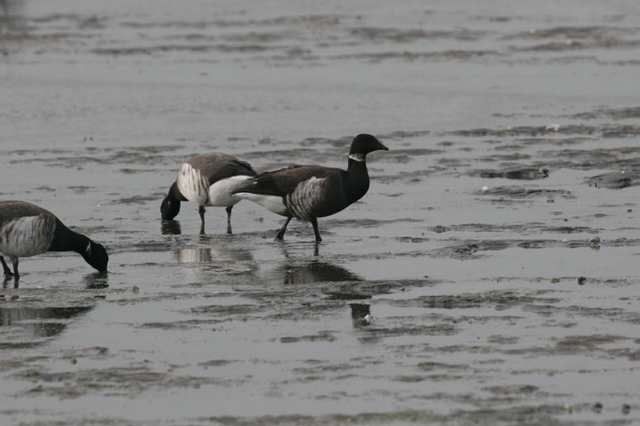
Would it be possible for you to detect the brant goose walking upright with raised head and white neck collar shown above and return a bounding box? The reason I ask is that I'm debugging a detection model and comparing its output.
[234,134,388,242]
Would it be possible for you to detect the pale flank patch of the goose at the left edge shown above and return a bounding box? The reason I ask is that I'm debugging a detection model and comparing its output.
[0,214,56,257]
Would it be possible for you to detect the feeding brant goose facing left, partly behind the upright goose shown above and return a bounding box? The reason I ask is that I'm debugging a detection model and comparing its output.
[160,153,256,234]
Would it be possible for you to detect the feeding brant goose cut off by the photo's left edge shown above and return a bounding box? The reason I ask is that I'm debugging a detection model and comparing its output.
[0,201,109,280]
